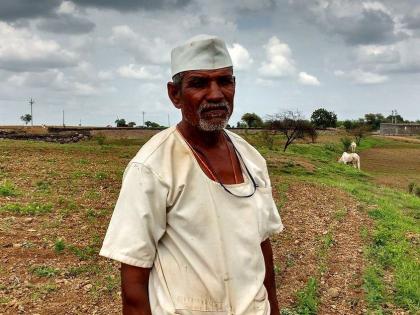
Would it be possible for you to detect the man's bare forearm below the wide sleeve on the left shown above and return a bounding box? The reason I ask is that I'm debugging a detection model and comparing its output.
[121,264,152,315]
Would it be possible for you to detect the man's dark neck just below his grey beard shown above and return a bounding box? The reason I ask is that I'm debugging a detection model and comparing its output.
[177,120,225,149]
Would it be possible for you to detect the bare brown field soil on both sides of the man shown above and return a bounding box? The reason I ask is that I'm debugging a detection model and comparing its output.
[0,141,370,314]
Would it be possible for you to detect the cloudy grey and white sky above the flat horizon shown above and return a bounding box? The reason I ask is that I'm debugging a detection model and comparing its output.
[0,0,420,125]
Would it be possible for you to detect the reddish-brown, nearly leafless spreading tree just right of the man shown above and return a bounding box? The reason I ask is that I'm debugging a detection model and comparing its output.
[267,110,316,151]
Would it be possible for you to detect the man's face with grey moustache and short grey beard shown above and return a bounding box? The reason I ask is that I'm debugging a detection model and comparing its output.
[180,67,235,131]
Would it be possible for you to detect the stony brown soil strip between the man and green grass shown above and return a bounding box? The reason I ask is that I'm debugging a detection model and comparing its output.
[272,183,369,314]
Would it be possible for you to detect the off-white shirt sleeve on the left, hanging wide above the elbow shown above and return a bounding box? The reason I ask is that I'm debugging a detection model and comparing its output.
[99,163,168,268]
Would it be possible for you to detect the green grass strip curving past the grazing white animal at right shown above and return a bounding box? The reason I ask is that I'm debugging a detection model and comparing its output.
[248,135,420,314]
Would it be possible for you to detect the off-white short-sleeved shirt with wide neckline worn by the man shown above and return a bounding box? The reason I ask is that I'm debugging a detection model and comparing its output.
[100,127,283,315]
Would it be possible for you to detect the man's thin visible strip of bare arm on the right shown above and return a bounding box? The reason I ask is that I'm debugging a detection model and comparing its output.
[261,238,280,315]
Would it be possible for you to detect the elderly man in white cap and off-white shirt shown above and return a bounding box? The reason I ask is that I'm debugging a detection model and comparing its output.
[100,35,283,315]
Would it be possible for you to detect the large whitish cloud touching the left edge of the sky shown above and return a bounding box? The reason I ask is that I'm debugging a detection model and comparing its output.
[0,22,77,72]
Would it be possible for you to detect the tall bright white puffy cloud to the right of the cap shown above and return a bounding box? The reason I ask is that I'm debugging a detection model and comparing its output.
[258,36,296,78]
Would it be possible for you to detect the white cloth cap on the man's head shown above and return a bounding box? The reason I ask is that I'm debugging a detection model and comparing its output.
[171,35,232,76]
